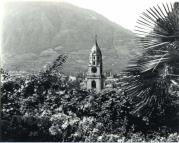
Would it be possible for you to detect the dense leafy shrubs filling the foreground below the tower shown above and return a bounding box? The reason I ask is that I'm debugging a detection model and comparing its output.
[1,63,179,141]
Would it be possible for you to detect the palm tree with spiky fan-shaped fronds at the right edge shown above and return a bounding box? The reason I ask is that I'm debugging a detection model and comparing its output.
[123,3,179,127]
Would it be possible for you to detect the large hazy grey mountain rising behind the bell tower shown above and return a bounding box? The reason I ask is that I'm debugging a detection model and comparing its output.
[2,1,140,73]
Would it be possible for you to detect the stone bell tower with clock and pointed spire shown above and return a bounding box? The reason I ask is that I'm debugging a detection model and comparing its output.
[87,36,103,92]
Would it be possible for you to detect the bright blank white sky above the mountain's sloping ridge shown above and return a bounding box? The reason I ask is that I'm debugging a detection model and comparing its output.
[63,0,179,31]
